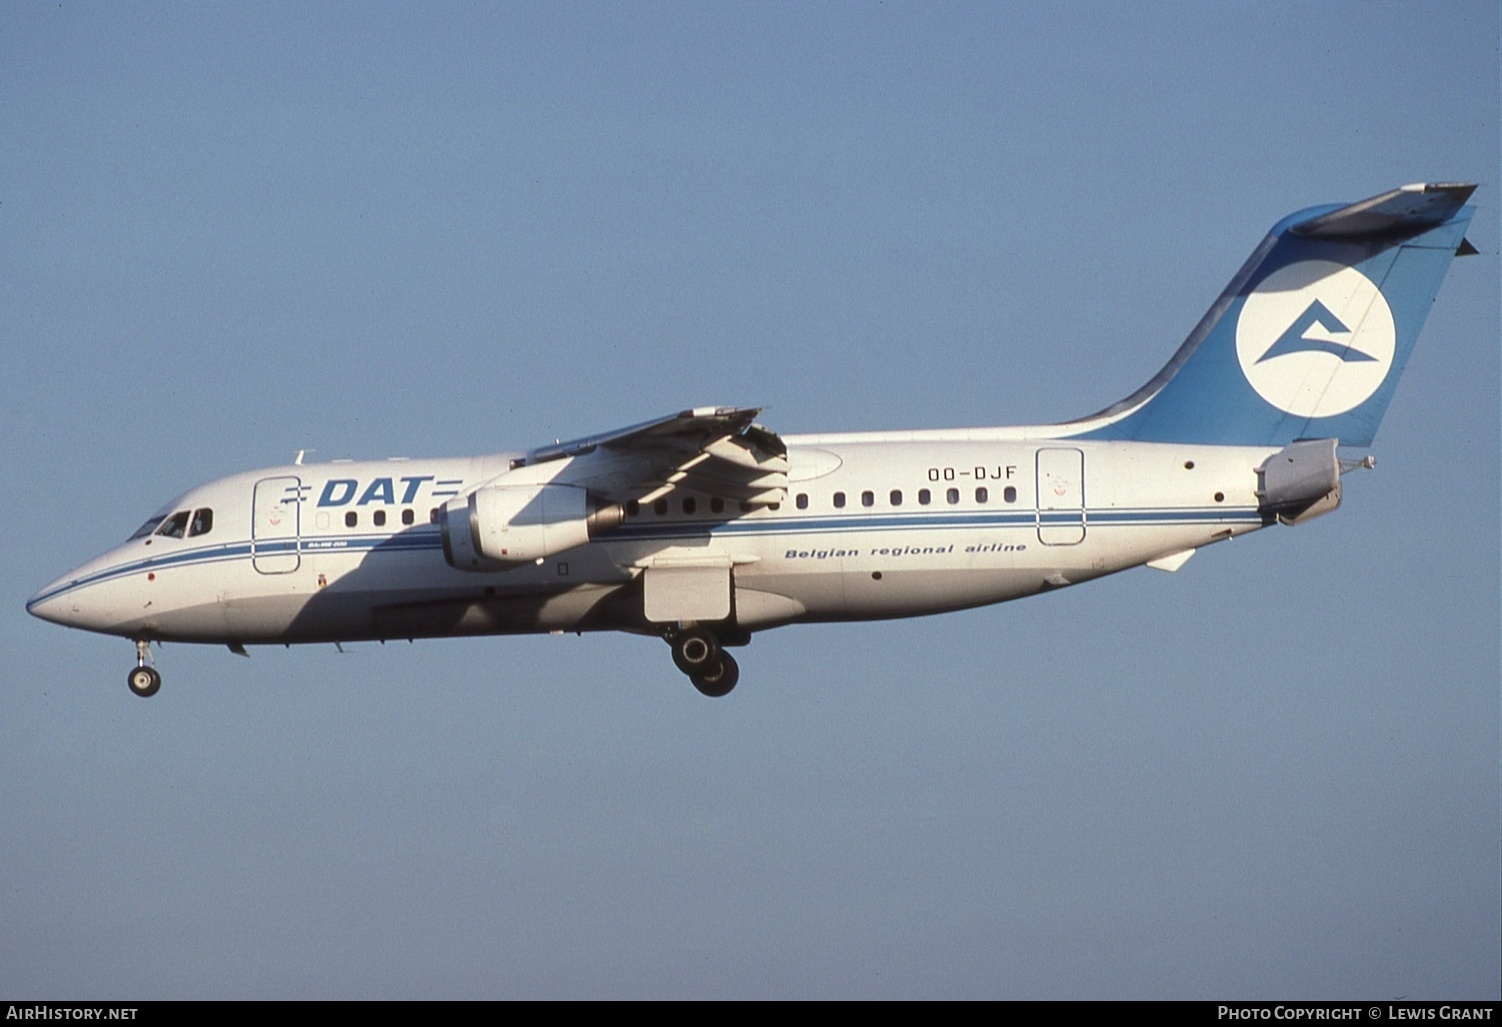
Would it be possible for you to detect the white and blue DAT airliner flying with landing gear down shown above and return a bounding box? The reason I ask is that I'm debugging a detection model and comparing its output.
[27,183,1475,697]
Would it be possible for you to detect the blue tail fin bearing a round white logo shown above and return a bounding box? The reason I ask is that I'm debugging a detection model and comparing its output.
[1060,183,1475,446]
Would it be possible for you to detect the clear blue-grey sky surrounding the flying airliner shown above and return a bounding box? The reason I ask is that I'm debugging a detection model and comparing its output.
[0,3,1502,998]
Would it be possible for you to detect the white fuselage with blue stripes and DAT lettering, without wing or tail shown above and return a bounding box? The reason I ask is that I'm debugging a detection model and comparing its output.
[29,428,1275,646]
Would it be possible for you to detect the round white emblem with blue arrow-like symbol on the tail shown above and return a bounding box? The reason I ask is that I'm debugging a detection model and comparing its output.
[1236,260,1397,417]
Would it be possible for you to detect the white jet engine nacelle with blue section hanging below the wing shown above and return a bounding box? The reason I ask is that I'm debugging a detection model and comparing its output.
[439,485,625,571]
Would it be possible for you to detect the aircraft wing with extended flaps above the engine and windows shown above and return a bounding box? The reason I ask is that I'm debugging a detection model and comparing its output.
[527,407,787,506]
